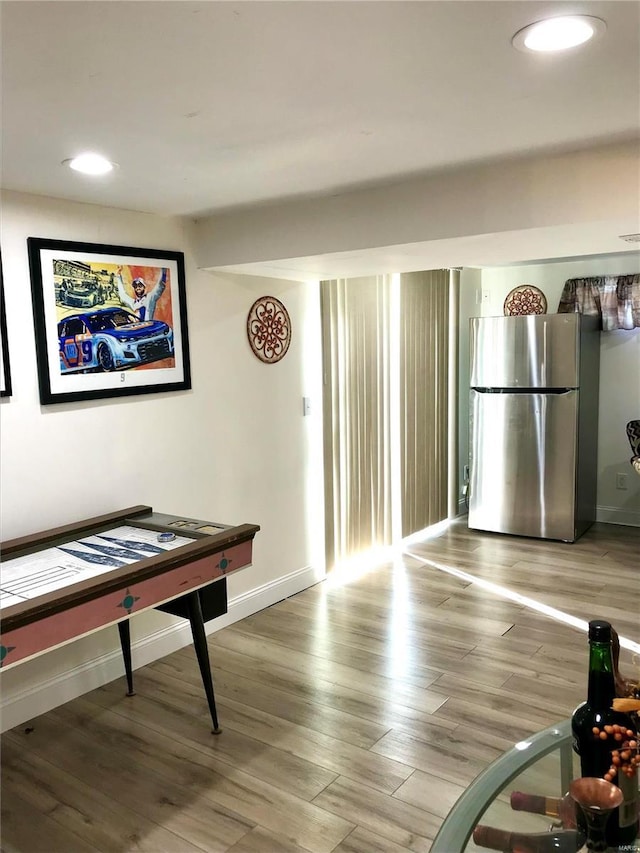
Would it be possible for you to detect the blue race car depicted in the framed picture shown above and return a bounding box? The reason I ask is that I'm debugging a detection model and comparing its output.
[58,308,174,374]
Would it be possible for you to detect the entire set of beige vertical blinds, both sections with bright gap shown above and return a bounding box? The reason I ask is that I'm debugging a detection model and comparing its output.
[320,270,449,567]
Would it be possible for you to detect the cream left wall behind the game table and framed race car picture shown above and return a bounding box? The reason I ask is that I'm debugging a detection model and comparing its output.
[0,192,324,728]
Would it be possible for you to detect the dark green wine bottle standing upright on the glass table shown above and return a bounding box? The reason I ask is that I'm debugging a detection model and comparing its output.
[571,619,638,847]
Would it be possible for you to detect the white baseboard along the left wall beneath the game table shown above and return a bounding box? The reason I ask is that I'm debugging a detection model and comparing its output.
[0,566,324,732]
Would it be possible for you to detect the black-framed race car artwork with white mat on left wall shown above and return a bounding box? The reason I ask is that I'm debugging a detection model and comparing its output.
[27,237,191,404]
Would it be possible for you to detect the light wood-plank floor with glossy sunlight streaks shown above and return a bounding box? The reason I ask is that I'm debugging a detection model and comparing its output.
[2,519,640,853]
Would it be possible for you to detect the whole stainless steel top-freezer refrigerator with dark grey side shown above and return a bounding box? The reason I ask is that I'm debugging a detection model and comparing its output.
[468,314,600,542]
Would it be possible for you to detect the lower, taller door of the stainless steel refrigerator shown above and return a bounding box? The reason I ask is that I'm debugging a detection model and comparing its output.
[469,390,578,542]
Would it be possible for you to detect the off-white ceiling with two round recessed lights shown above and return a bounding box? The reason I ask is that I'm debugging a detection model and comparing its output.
[0,0,640,272]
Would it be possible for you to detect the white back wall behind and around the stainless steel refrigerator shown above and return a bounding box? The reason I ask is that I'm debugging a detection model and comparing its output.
[461,253,640,526]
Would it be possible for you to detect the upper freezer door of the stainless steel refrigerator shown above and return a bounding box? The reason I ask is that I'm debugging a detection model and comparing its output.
[469,314,580,388]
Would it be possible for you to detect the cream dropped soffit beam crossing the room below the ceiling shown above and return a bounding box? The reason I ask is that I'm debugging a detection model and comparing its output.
[195,142,639,278]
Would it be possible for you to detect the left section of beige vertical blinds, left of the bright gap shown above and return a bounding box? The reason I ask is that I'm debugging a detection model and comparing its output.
[321,276,391,565]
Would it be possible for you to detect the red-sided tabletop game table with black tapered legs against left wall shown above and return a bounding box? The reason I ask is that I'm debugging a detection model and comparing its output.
[0,506,260,733]
